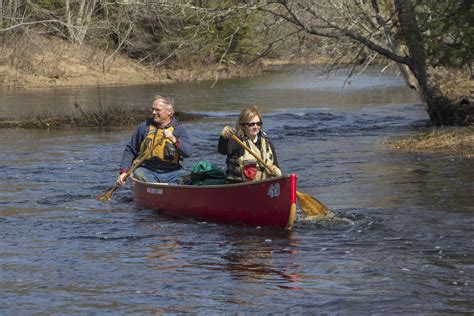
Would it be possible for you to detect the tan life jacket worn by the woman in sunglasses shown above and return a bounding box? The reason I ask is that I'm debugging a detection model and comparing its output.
[238,136,274,182]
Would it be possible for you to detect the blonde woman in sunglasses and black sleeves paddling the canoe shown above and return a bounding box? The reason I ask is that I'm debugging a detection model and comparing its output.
[218,106,281,183]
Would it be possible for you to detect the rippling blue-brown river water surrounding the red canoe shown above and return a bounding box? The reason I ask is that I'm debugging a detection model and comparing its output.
[0,73,474,315]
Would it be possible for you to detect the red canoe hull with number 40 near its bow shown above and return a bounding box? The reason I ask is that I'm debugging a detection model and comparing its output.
[131,174,296,229]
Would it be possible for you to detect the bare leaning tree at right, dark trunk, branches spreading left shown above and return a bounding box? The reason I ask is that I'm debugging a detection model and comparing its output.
[246,0,474,125]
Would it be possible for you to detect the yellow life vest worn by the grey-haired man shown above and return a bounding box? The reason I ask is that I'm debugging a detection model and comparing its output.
[140,124,180,164]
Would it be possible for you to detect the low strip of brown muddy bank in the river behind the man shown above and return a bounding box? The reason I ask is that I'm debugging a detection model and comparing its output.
[0,108,205,129]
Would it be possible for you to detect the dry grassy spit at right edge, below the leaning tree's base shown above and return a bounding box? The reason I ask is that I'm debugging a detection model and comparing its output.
[387,126,474,158]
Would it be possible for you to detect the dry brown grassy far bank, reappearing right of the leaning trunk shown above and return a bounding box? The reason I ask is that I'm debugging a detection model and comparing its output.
[0,35,474,103]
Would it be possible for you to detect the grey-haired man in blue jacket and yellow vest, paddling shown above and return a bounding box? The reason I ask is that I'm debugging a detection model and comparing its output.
[117,95,193,186]
